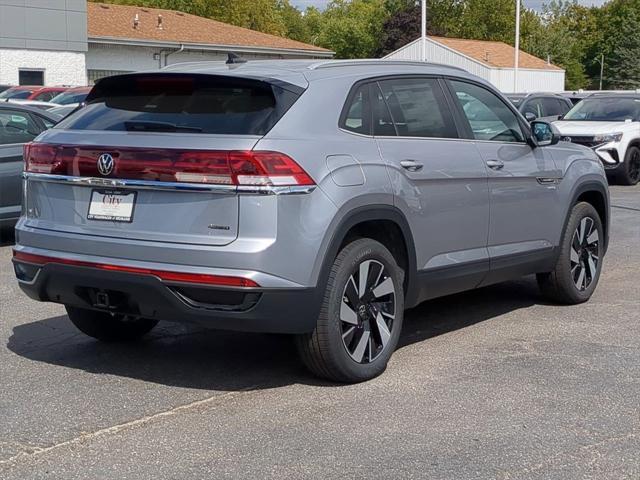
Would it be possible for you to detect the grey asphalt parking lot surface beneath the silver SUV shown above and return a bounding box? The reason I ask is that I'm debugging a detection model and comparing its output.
[0,186,640,480]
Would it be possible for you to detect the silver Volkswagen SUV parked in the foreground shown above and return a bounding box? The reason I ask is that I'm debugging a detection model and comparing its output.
[13,61,609,382]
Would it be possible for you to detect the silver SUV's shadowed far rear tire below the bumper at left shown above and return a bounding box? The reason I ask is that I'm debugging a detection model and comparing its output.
[65,306,158,342]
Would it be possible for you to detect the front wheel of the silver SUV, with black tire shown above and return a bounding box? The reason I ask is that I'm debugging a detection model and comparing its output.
[537,202,604,305]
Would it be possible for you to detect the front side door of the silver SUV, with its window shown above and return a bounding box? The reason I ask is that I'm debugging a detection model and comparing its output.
[448,80,562,282]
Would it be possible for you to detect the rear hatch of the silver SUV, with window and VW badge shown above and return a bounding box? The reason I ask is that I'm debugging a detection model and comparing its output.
[25,73,301,245]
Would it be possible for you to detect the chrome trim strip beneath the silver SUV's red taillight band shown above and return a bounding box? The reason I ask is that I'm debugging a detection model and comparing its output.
[23,172,316,195]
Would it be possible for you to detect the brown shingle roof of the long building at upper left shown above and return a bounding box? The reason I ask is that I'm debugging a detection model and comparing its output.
[87,2,328,53]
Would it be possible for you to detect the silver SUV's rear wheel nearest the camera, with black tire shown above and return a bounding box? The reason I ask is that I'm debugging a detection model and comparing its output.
[296,238,404,383]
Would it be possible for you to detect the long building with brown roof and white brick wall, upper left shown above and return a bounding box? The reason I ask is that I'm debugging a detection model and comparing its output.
[0,0,333,85]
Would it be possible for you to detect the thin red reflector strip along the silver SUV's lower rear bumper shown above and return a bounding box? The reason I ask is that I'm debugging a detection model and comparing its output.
[13,250,260,287]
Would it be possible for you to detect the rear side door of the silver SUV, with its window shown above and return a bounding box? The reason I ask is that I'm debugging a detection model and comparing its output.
[371,76,489,298]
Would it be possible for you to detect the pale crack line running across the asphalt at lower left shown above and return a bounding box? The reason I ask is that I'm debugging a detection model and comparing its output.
[0,386,257,467]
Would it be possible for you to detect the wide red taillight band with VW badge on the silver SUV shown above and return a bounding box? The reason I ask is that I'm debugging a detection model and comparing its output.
[24,143,315,187]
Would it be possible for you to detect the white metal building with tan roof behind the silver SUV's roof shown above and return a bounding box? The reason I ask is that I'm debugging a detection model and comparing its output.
[384,36,565,92]
